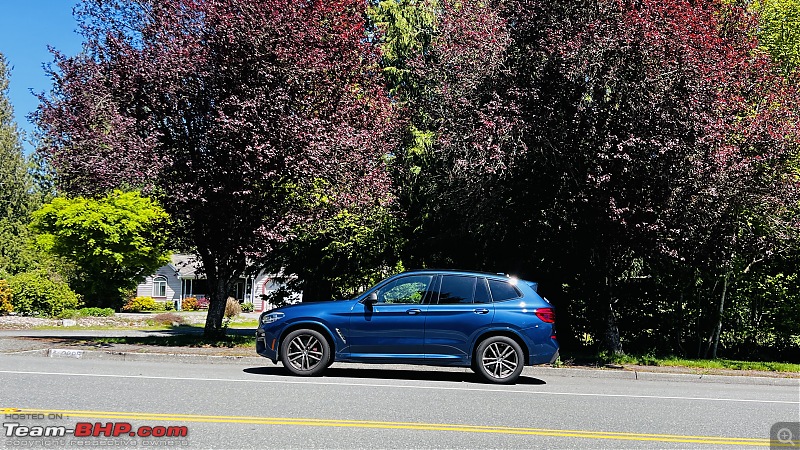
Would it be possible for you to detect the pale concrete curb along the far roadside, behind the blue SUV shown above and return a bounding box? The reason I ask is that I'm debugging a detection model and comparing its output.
[3,348,800,387]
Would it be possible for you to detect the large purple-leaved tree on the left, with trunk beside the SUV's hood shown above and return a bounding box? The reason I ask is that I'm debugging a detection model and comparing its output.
[36,0,394,335]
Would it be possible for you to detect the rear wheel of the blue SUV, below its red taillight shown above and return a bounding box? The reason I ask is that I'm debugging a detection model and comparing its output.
[472,336,525,384]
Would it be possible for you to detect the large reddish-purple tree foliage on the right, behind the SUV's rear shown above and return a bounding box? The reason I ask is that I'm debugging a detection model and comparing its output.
[376,0,800,352]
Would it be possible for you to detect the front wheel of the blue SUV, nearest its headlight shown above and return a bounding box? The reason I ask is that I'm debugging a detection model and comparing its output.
[281,329,332,377]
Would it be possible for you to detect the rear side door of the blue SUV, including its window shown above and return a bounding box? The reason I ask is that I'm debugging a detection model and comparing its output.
[425,274,494,364]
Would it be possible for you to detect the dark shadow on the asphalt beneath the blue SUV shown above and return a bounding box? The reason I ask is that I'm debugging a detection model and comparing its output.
[243,366,547,385]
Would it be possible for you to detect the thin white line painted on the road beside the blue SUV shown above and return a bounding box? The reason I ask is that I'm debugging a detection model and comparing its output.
[0,370,800,405]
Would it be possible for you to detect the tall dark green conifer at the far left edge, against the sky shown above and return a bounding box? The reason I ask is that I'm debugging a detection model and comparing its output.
[0,54,36,274]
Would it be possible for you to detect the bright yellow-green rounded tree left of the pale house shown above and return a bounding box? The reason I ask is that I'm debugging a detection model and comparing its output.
[33,191,169,307]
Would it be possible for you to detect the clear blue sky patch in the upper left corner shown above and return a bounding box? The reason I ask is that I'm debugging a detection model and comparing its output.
[0,0,81,153]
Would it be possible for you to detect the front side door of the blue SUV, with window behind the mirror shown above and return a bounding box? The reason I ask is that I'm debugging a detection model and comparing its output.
[348,274,435,362]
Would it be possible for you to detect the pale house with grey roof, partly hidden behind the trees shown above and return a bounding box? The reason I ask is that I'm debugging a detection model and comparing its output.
[136,254,301,311]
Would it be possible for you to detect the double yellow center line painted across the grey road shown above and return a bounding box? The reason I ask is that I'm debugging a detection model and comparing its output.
[1,409,789,447]
